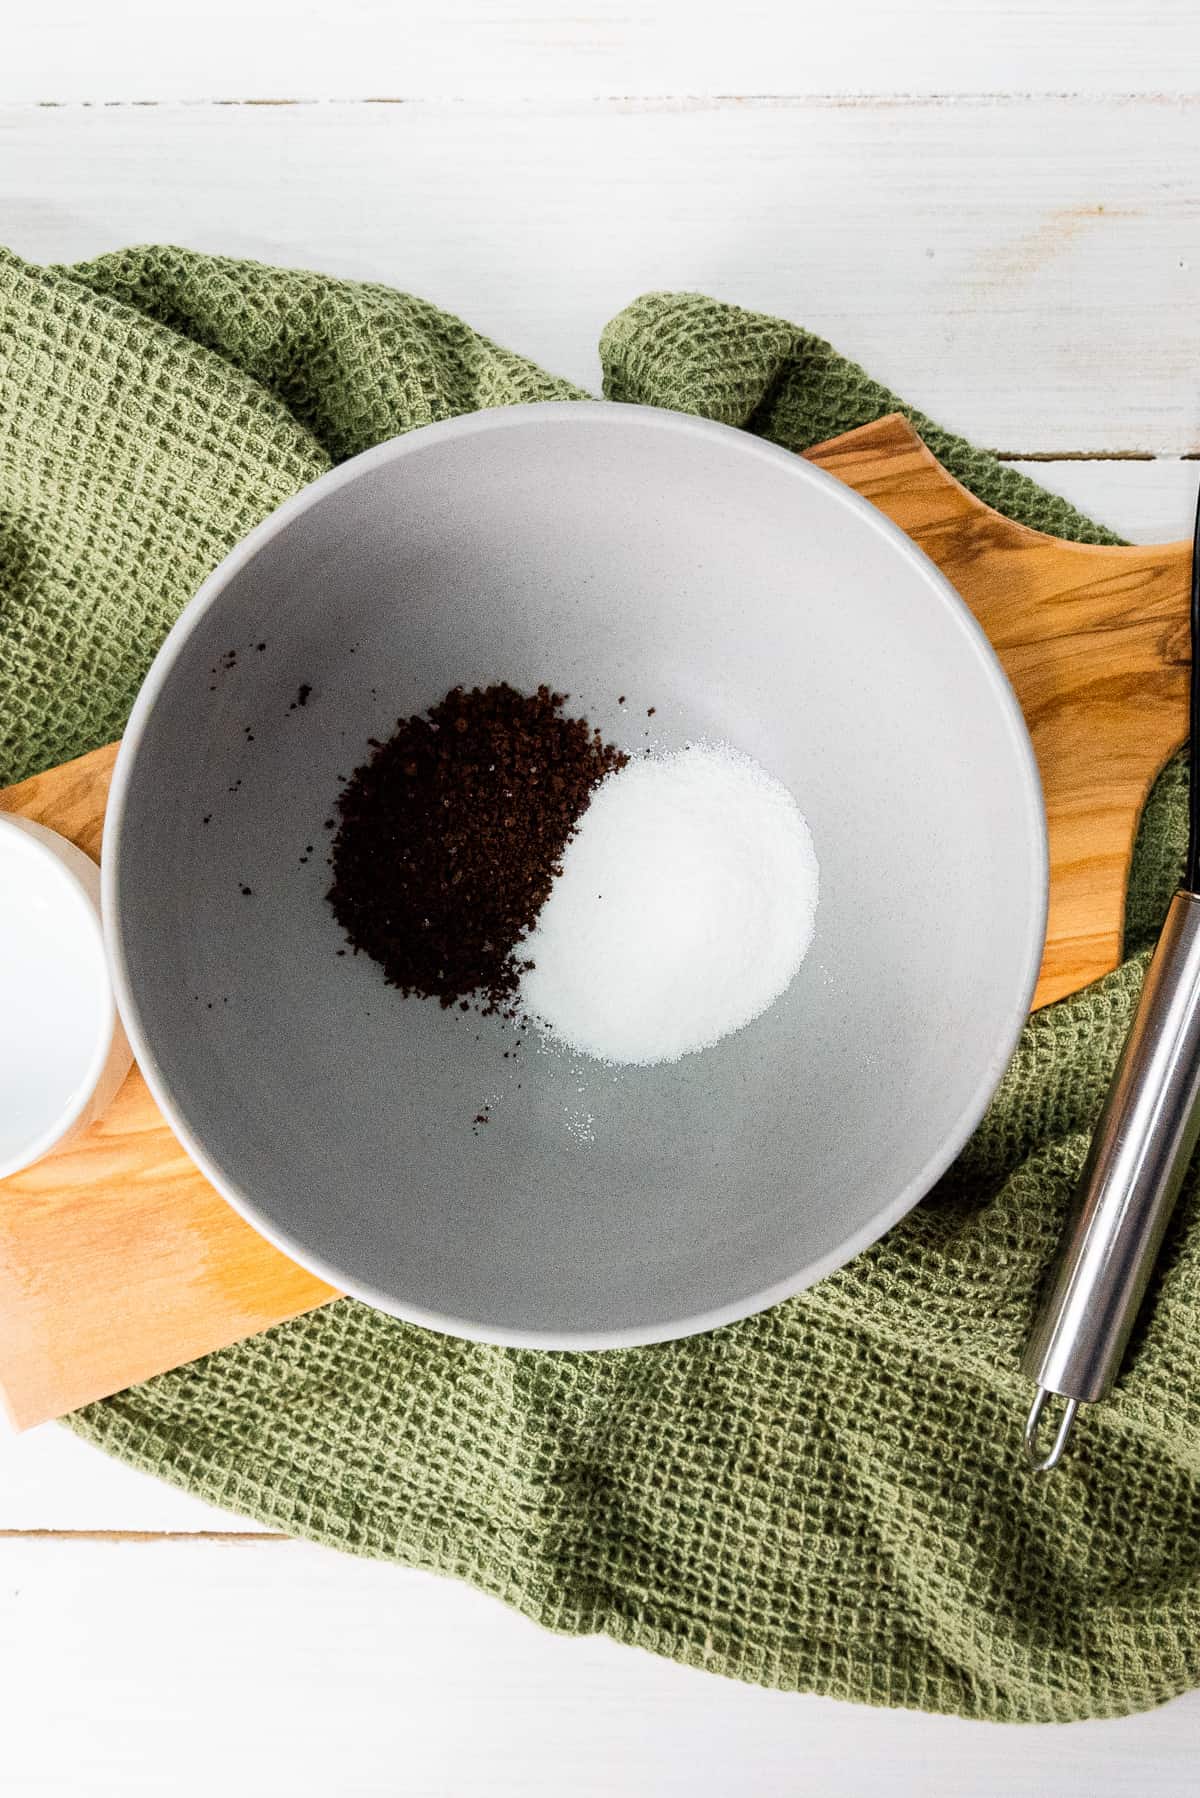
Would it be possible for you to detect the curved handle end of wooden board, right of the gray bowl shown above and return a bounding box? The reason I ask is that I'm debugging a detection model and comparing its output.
[808,414,1191,1009]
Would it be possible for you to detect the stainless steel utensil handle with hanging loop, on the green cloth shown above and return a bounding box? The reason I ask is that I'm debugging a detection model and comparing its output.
[1022,892,1200,1471]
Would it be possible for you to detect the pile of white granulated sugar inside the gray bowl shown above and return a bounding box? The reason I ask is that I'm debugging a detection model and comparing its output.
[520,744,817,1066]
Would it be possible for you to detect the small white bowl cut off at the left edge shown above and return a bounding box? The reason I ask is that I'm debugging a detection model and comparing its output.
[0,814,133,1178]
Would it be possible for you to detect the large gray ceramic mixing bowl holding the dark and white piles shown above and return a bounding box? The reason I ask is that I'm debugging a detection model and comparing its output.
[104,403,1047,1349]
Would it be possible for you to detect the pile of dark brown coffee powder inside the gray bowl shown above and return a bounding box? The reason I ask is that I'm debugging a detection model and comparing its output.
[329,685,628,1014]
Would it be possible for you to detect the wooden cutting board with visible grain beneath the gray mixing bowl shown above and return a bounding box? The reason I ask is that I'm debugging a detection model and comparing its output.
[0,417,1191,1429]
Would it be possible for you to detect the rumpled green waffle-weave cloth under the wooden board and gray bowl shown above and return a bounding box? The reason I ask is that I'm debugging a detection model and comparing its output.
[0,248,1200,1721]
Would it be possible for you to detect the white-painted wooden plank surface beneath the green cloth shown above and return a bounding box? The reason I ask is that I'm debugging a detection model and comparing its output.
[0,0,1200,1798]
